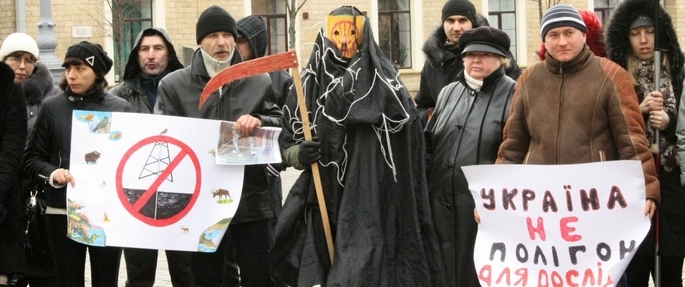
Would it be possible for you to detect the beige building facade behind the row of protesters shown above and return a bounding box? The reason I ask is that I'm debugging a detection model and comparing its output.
[0,0,685,93]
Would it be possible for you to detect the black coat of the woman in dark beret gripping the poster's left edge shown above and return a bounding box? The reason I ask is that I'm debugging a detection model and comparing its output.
[24,87,132,209]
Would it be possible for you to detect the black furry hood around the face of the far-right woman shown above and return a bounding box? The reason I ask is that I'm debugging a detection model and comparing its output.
[605,0,685,73]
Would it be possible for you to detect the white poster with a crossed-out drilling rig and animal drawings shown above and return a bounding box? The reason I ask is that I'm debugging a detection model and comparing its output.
[67,111,244,252]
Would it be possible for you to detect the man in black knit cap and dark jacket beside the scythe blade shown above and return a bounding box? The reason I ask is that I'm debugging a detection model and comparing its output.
[154,6,281,286]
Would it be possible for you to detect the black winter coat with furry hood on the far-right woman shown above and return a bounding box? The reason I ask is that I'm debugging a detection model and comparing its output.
[606,0,685,257]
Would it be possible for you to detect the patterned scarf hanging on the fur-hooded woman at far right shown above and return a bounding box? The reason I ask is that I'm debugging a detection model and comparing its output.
[629,55,678,172]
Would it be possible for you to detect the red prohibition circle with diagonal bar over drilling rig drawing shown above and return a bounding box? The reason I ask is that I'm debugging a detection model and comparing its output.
[116,135,202,226]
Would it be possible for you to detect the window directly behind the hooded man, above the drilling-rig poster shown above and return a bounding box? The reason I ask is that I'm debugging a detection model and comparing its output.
[111,0,152,81]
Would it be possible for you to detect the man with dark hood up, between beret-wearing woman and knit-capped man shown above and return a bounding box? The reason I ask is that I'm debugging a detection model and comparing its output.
[110,28,192,287]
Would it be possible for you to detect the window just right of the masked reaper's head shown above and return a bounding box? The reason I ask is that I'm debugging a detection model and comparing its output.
[378,0,411,68]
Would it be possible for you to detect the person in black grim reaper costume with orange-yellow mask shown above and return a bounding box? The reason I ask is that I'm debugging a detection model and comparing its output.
[272,6,444,286]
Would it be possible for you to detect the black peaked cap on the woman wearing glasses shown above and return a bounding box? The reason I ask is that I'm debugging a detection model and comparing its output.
[457,26,511,57]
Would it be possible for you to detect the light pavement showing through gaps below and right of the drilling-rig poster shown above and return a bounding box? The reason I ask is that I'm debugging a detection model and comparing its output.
[85,168,300,287]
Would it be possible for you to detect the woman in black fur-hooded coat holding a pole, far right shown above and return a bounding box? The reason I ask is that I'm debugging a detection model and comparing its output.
[606,0,685,287]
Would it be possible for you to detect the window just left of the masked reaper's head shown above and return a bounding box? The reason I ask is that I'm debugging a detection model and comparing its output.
[252,0,288,55]
